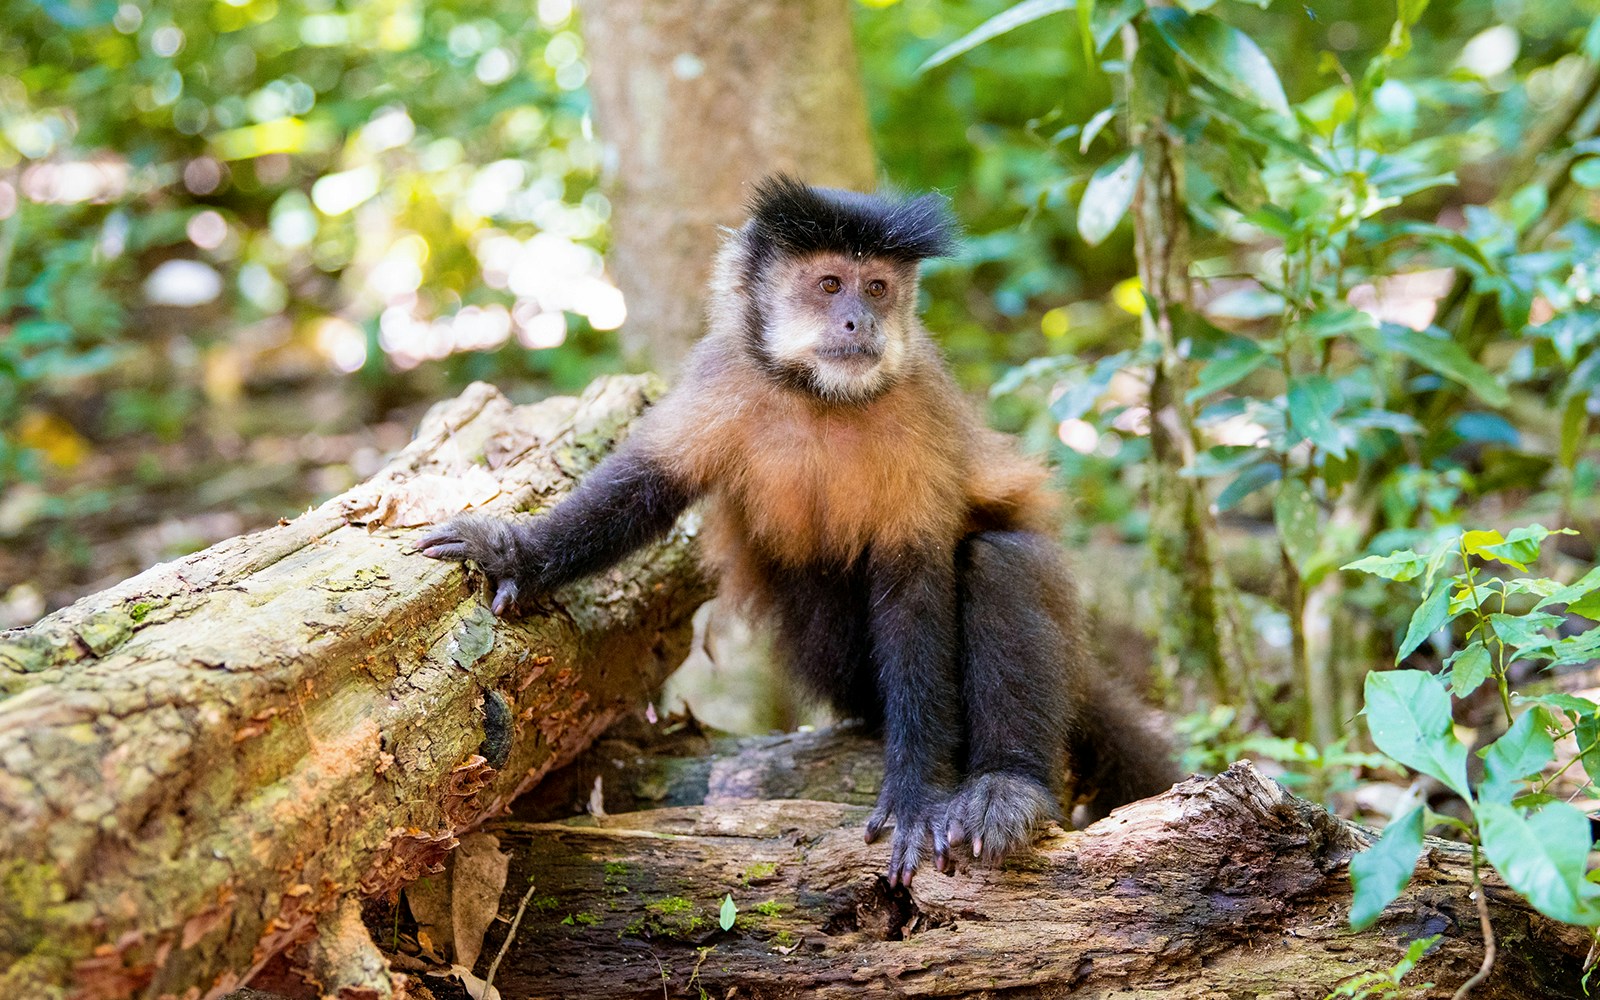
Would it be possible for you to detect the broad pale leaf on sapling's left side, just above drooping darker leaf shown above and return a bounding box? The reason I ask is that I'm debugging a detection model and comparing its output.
[1365,670,1472,802]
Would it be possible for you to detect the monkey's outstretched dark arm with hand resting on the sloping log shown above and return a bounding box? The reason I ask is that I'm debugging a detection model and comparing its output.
[416,435,696,614]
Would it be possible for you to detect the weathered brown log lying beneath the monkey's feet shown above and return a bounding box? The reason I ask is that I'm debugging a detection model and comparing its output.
[467,752,1589,1000]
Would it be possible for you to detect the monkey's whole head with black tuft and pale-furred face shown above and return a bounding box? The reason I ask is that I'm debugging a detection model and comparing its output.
[725,174,955,403]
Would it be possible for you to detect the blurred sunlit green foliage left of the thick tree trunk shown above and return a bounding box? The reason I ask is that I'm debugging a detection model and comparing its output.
[0,0,616,478]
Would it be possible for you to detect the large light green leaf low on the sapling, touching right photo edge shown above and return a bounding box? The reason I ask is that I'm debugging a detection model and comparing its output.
[1477,802,1600,926]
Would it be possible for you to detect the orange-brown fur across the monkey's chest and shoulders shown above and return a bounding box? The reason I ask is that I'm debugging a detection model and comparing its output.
[636,339,1051,603]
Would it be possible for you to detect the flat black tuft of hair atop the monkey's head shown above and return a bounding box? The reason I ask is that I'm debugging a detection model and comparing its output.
[750,174,958,264]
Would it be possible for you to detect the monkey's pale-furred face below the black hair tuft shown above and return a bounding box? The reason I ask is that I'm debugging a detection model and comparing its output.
[762,253,917,402]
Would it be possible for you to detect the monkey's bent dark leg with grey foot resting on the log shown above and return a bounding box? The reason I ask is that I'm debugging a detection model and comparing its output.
[949,531,1082,862]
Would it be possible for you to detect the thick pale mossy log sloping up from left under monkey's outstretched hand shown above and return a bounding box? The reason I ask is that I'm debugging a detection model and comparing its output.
[0,378,710,1000]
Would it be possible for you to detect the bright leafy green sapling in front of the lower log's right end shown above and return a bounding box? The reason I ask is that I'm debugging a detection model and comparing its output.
[1344,525,1600,985]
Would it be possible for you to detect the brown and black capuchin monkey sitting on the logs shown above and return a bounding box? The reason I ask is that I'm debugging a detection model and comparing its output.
[416,176,1176,885]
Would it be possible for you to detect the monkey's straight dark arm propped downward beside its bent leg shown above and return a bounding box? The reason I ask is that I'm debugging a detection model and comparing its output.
[867,546,962,885]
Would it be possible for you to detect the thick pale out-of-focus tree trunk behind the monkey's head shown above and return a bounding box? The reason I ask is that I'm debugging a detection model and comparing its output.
[581,0,874,371]
